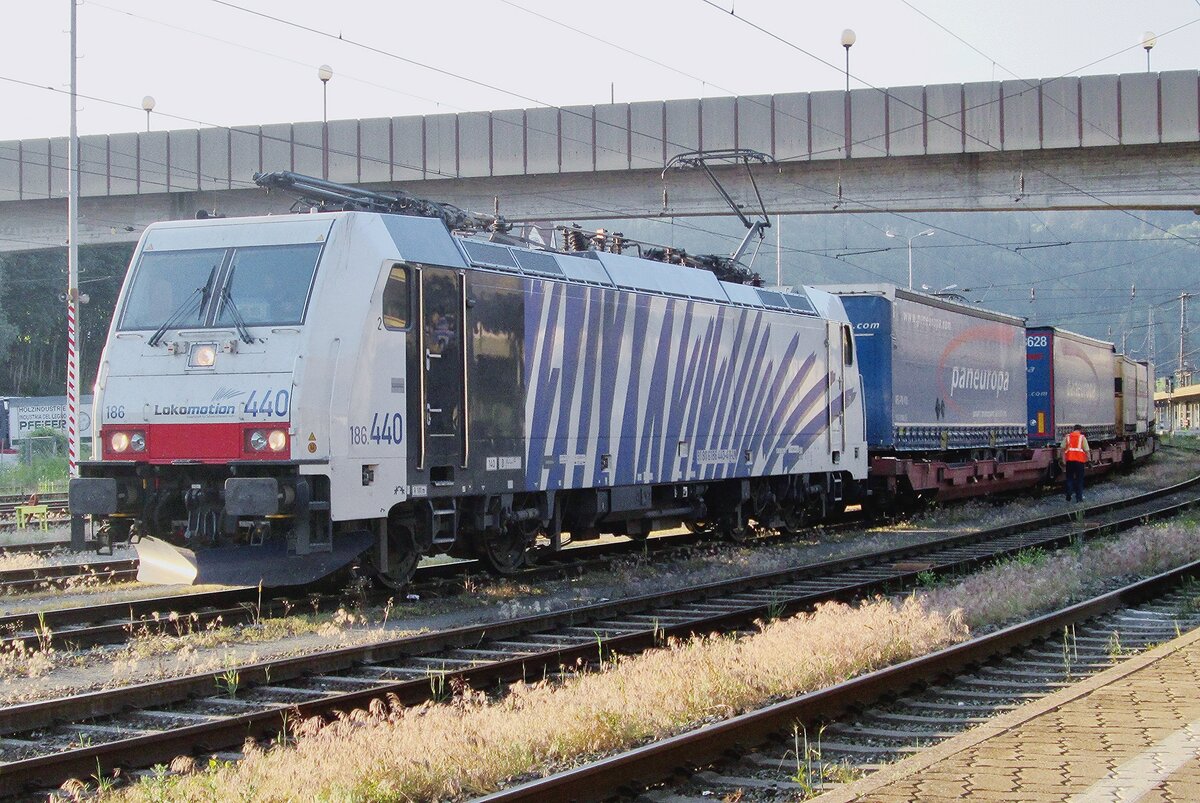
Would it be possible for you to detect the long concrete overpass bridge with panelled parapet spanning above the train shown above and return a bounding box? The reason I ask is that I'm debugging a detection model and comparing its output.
[0,70,1200,251]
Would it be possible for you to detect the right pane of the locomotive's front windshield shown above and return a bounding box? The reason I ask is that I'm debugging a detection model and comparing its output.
[217,242,320,326]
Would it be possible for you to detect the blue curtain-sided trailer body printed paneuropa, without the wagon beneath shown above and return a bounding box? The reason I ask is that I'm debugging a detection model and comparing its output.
[826,284,1026,454]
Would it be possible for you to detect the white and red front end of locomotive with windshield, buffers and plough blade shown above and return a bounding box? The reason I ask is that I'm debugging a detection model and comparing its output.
[70,212,374,585]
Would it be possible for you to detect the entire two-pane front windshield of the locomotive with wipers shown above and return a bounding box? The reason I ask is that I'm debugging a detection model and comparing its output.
[120,242,322,329]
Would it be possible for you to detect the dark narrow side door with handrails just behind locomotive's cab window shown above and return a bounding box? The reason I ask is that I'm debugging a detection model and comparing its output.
[418,266,467,472]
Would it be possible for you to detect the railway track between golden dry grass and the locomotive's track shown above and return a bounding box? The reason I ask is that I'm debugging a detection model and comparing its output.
[0,479,1200,793]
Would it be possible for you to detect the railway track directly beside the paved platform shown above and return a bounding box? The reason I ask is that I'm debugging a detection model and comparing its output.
[480,562,1200,803]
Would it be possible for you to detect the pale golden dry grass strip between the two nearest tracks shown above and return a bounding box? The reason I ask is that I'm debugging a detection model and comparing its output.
[105,600,966,801]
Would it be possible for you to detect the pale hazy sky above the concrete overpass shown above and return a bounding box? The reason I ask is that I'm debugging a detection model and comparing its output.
[0,0,1200,140]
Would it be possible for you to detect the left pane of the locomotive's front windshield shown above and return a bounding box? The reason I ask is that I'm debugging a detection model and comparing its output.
[121,248,226,329]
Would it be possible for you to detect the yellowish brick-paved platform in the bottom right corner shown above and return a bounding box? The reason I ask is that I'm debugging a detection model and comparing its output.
[817,630,1200,803]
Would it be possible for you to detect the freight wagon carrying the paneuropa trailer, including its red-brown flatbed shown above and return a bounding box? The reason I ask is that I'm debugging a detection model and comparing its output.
[827,284,1054,509]
